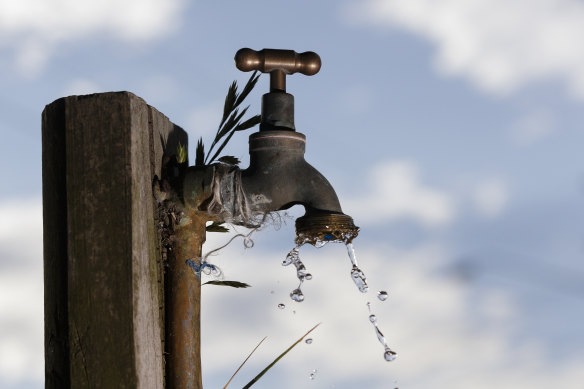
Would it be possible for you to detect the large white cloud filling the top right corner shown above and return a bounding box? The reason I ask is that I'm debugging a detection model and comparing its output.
[346,0,584,98]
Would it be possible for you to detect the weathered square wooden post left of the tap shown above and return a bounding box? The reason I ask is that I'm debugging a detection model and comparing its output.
[42,92,189,389]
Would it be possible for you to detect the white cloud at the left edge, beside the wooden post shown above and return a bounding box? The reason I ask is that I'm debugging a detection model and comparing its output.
[0,198,44,384]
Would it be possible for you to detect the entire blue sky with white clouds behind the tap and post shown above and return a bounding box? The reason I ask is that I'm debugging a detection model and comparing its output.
[0,0,584,389]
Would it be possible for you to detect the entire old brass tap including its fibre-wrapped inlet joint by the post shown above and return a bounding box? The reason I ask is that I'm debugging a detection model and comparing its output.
[179,49,359,245]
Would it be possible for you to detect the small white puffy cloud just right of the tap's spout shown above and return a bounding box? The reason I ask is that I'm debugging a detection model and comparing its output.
[343,161,454,226]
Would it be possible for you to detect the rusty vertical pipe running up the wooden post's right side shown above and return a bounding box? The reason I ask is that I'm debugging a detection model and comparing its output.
[166,209,205,389]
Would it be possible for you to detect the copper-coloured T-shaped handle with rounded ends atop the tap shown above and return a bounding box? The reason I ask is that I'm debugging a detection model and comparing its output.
[235,48,321,92]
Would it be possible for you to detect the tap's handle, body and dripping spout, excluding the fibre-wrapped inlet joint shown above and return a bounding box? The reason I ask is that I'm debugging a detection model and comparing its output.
[235,48,359,244]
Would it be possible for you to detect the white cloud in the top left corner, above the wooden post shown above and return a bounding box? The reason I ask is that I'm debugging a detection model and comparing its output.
[0,0,184,77]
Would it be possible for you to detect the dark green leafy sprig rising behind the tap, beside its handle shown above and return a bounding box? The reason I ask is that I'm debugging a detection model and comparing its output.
[203,72,261,165]
